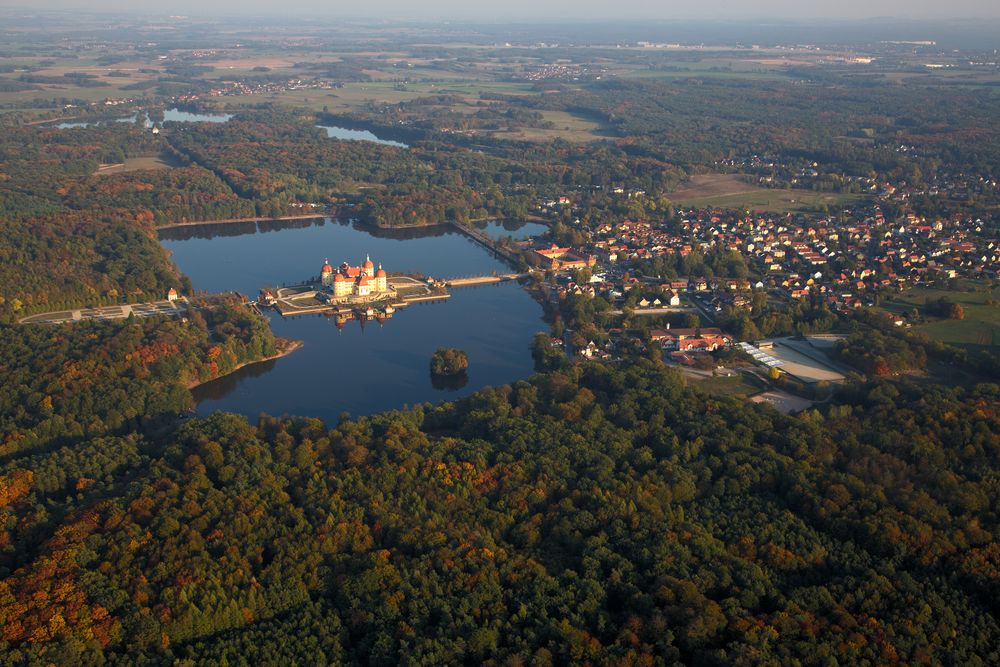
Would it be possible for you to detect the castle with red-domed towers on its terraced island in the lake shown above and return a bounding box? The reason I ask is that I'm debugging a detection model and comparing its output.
[258,257,451,324]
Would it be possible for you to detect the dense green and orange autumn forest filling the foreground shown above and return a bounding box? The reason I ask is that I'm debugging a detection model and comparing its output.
[0,362,1000,665]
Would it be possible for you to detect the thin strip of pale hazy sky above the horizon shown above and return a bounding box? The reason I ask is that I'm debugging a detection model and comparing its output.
[0,0,1000,20]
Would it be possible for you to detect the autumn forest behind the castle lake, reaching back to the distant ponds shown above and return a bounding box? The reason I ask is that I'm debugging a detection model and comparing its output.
[169,109,684,227]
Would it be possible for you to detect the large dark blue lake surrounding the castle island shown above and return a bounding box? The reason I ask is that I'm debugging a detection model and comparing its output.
[160,218,546,423]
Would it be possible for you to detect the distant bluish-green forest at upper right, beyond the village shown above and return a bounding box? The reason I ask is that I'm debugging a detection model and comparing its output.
[504,77,1000,181]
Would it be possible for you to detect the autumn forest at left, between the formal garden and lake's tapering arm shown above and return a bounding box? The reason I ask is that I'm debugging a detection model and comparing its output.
[0,297,277,458]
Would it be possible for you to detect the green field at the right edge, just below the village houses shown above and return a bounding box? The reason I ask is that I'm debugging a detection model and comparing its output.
[883,287,1000,351]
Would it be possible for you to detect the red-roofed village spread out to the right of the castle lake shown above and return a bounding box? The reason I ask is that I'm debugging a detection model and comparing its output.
[523,180,1000,402]
